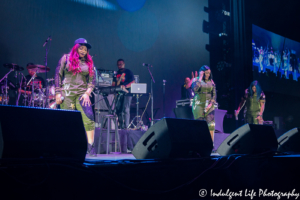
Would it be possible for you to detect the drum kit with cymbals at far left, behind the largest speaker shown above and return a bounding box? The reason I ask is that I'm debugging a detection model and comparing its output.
[0,63,56,109]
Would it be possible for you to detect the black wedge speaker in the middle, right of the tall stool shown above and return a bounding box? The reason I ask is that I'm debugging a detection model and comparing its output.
[132,118,213,159]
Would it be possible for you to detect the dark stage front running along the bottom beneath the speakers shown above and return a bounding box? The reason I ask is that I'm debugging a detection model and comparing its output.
[0,153,300,199]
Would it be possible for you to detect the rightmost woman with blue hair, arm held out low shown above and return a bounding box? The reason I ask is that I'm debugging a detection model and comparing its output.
[235,81,266,124]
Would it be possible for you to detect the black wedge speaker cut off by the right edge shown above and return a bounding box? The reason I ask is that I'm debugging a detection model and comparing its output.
[278,128,300,153]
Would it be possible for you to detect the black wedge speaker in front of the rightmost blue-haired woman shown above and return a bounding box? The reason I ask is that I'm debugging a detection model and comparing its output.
[217,124,278,156]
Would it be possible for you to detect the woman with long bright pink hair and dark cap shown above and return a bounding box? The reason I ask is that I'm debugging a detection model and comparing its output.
[55,38,95,155]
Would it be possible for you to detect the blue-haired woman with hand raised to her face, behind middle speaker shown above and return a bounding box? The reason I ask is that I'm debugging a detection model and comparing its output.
[192,65,216,141]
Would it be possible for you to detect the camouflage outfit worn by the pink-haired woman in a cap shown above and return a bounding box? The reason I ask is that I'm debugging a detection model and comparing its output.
[55,54,96,131]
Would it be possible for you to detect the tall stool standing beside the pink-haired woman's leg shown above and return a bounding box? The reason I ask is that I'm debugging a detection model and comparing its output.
[98,115,121,154]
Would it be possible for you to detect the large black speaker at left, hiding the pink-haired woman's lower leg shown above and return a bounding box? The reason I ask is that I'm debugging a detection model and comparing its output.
[0,106,87,162]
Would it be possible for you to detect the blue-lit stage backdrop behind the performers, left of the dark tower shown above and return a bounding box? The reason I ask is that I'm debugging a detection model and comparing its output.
[0,0,210,118]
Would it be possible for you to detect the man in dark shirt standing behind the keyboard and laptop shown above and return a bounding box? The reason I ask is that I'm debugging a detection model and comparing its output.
[112,59,135,129]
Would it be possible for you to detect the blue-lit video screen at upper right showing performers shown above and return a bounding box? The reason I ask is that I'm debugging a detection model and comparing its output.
[252,25,300,96]
